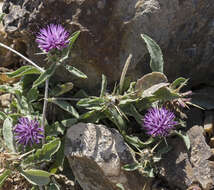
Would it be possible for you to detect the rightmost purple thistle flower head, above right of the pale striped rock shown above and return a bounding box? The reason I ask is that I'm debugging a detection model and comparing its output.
[143,108,178,137]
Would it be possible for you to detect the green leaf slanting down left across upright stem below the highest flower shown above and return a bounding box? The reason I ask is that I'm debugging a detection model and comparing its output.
[32,63,57,88]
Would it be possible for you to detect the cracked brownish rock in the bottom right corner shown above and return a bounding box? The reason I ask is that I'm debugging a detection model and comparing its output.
[160,126,214,190]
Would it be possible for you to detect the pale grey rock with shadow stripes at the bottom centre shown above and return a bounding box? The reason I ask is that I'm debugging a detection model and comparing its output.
[65,123,149,190]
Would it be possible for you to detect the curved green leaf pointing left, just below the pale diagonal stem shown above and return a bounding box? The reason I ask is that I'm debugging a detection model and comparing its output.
[6,65,41,78]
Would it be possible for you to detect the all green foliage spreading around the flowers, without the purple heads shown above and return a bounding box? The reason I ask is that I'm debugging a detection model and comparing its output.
[0,31,194,190]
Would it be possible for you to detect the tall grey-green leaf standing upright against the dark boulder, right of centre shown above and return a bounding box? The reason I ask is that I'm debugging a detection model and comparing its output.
[141,34,164,73]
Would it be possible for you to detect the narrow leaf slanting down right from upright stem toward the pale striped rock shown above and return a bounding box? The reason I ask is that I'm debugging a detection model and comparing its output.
[48,98,79,118]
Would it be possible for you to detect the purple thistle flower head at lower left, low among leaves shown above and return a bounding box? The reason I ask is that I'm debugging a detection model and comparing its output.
[14,117,44,146]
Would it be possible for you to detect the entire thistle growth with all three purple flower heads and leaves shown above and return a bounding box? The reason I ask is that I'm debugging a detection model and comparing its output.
[0,28,195,189]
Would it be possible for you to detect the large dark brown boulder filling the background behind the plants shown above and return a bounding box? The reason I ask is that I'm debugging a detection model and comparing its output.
[3,0,214,88]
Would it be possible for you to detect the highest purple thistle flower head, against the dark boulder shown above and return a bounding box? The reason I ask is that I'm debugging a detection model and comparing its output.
[36,24,69,53]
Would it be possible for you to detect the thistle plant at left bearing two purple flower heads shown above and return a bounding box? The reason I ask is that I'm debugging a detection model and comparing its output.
[0,24,83,189]
